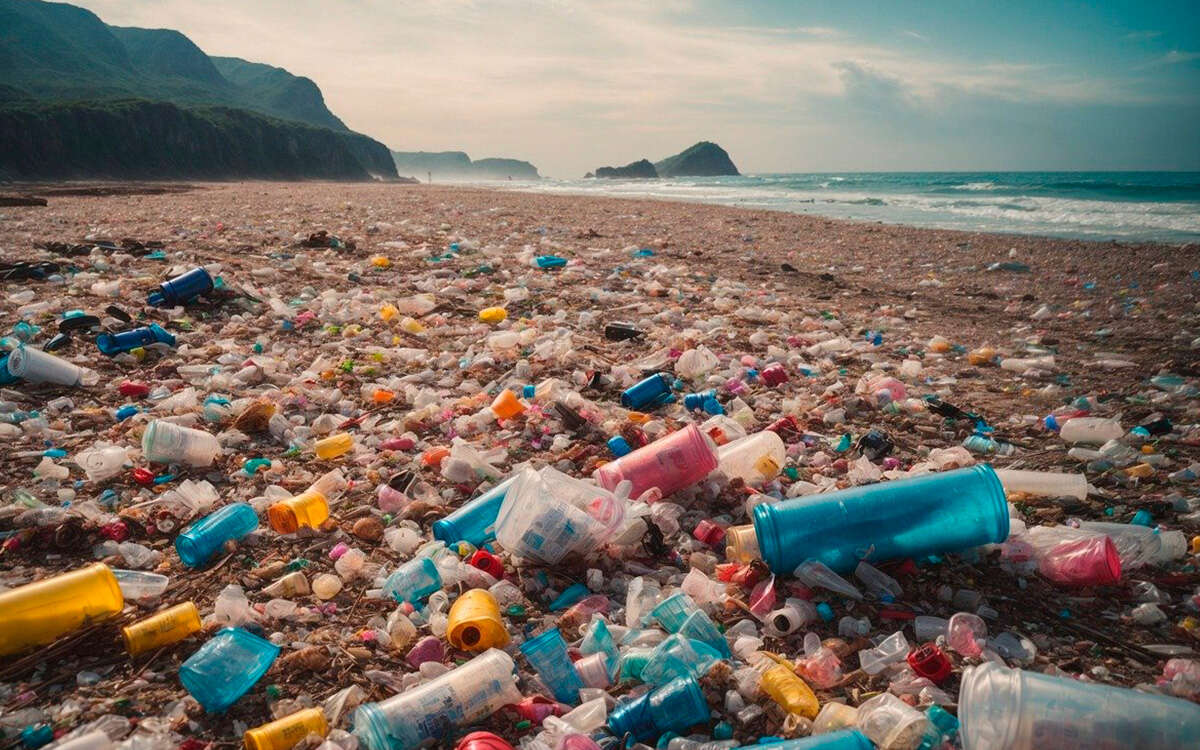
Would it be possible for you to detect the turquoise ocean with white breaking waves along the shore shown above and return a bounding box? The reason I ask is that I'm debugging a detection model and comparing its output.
[508,172,1200,244]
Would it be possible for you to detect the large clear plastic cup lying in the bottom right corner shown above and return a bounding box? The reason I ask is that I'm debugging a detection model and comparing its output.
[959,661,1200,750]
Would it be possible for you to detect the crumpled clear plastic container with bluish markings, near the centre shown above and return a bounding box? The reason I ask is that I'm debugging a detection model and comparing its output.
[496,467,624,565]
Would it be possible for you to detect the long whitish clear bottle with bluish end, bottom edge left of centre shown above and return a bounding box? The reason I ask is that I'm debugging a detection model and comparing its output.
[354,648,521,750]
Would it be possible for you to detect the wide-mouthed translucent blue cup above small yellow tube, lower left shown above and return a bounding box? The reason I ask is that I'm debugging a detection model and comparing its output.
[179,628,280,714]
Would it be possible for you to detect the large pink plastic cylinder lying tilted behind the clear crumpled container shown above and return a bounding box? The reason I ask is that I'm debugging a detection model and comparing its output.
[594,425,715,498]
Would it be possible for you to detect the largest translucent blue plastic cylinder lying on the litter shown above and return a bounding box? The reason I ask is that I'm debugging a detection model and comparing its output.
[754,464,1008,574]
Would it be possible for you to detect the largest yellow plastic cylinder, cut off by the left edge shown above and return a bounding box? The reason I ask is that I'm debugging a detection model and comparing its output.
[0,563,125,656]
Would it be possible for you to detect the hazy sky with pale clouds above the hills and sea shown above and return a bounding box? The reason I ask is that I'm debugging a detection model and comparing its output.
[74,0,1200,178]
